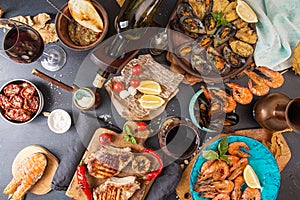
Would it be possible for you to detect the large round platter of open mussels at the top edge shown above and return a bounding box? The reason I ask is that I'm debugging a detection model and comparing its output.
[169,0,258,80]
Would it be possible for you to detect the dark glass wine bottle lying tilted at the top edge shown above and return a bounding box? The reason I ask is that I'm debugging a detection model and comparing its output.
[92,0,163,88]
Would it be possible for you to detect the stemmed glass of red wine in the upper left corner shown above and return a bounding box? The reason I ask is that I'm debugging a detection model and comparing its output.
[0,18,66,71]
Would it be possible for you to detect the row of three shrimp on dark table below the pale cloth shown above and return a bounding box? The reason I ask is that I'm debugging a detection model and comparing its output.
[226,66,284,104]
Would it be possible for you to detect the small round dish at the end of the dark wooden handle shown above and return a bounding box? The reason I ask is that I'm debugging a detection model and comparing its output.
[73,88,96,110]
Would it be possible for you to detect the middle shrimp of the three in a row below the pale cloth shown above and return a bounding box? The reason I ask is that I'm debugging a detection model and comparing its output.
[244,70,270,96]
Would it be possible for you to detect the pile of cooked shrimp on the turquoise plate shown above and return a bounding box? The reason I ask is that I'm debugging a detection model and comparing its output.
[194,142,261,200]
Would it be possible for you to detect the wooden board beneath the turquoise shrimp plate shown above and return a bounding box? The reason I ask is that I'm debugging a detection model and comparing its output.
[176,128,292,200]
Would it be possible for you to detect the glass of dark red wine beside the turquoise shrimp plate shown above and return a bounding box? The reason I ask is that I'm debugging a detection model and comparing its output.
[158,117,200,160]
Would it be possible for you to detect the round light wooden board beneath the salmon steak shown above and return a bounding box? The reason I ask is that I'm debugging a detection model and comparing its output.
[12,145,59,195]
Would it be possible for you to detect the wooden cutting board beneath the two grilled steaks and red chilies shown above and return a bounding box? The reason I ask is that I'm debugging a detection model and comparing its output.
[66,128,158,200]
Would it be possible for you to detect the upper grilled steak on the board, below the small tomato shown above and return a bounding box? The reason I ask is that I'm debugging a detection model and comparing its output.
[84,146,133,179]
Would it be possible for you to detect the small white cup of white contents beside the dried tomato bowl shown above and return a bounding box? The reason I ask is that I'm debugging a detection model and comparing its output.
[47,109,72,134]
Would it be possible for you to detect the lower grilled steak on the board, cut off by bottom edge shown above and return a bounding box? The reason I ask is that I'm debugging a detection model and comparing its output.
[93,176,140,200]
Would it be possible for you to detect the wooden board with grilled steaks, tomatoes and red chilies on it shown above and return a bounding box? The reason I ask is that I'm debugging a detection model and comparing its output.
[66,128,163,200]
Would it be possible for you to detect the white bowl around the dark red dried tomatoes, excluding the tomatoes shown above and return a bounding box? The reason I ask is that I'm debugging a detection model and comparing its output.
[0,79,44,125]
